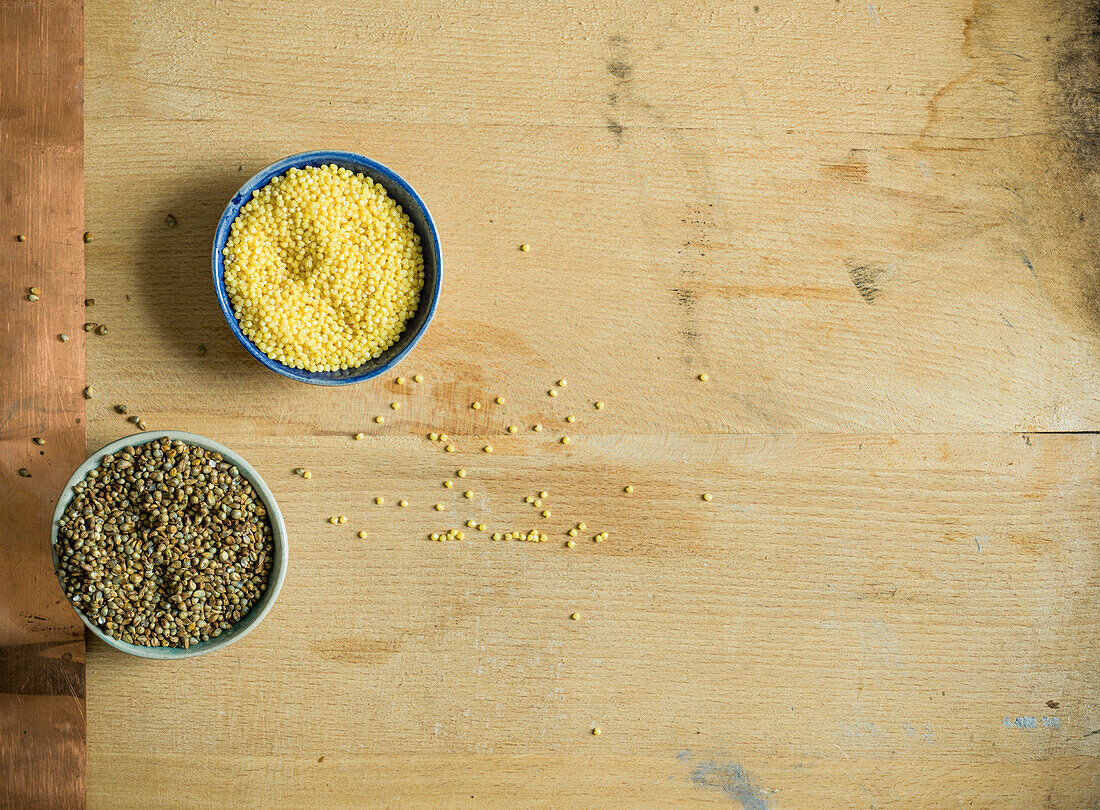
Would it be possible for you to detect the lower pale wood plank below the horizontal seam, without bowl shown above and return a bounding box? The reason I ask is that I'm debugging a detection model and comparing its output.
[89,436,1100,807]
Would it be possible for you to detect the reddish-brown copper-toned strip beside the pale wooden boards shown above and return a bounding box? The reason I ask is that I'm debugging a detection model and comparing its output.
[0,0,86,810]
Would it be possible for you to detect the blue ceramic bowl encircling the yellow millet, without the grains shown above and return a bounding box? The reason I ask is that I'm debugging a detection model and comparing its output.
[211,151,443,385]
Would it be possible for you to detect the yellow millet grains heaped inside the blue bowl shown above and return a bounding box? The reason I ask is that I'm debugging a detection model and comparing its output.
[222,164,424,371]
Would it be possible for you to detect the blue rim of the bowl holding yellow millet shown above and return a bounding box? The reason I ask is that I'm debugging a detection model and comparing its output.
[210,150,443,386]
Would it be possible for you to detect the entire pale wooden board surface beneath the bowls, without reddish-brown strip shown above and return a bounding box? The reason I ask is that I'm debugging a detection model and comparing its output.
[83,0,1100,810]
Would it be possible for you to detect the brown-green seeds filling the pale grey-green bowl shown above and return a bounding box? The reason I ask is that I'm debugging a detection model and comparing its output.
[56,438,274,648]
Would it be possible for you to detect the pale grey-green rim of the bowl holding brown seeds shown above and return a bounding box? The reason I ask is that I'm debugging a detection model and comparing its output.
[50,430,289,660]
